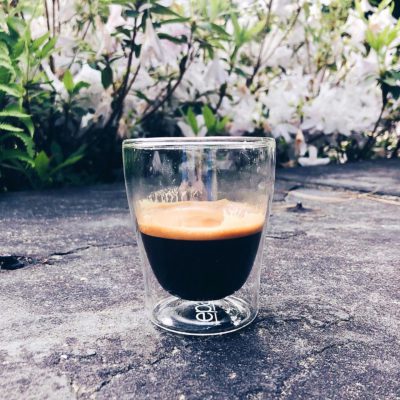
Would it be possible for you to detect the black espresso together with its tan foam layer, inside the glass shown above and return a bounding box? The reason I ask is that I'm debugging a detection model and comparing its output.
[137,200,264,301]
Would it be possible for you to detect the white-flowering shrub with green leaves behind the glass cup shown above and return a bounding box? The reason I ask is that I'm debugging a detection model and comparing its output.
[0,0,400,189]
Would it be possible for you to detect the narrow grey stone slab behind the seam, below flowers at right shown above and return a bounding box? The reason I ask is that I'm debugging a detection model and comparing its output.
[277,160,400,196]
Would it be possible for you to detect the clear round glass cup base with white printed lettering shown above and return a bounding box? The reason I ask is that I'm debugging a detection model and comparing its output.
[152,296,257,336]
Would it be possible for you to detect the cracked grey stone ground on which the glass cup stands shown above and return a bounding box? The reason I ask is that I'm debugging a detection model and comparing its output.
[0,161,400,400]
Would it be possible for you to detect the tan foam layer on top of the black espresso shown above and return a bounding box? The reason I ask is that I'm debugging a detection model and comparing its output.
[135,200,265,240]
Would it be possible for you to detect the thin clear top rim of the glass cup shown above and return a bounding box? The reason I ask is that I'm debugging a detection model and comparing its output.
[122,136,275,150]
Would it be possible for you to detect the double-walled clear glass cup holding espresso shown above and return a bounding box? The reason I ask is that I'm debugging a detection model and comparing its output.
[123,137,275,335]
